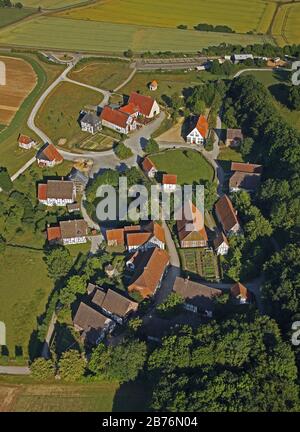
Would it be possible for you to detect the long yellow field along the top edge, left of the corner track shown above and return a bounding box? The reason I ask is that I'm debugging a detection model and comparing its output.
[59,0,275,33]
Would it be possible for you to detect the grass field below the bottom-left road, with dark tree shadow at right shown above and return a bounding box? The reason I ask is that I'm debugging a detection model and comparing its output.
[0,377,150,412]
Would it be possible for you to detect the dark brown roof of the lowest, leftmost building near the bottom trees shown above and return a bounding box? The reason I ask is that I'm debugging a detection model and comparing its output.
[73,302,111,332]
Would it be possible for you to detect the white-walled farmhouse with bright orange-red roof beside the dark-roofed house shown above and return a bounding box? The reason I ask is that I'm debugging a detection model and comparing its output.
[100,106,137,134]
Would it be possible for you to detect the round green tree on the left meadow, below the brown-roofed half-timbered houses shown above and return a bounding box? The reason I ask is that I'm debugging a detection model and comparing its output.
[46,247,73,280]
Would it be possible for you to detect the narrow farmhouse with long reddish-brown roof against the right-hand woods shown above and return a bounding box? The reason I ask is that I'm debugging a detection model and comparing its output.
[215,195,241,235]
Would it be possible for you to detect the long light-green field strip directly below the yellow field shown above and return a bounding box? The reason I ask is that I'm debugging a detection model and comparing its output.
[0,16,273,53]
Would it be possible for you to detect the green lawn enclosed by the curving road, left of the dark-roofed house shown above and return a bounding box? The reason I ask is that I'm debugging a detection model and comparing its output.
[36,83,103,148]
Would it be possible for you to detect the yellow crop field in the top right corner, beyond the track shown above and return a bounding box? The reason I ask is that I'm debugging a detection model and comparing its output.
[272,3,300,46]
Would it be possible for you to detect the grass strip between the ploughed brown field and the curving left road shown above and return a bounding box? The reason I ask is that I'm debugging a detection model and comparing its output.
[0,53,64,175]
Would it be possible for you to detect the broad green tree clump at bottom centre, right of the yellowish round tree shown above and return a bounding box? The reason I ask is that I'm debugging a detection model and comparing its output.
[89,340,147,383]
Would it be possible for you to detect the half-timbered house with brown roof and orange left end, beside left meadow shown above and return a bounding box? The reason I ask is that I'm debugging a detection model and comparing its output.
[38,180,76,207]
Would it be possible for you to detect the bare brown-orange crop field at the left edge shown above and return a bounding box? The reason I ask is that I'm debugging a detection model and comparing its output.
[0,57,37,125]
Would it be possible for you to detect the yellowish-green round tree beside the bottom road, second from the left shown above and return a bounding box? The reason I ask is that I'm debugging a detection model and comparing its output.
[58,350,86,381]
